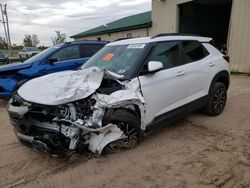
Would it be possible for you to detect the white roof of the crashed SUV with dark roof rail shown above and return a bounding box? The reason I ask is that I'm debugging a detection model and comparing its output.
[107,35,212,46]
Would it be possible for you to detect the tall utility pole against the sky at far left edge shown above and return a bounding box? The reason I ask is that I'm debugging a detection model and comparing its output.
[0,4,11,56]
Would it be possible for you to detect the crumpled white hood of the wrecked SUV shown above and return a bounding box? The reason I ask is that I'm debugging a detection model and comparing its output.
[18,67,104,105]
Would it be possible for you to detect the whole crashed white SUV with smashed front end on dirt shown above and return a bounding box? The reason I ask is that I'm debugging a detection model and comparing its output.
[8,35,229,156]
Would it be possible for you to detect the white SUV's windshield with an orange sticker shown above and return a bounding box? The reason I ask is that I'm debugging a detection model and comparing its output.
[82,44,145,75]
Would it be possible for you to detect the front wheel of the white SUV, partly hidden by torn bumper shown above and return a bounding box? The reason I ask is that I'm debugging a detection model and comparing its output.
[103,109,141,154]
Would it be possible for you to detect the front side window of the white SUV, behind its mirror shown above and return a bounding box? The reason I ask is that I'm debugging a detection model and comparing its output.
[149,42,181,69]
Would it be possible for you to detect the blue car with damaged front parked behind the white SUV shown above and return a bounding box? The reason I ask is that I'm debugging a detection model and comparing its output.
[0,41,107,99]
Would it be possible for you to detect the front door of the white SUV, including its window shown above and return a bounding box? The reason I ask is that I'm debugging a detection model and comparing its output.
[139,41,187,124]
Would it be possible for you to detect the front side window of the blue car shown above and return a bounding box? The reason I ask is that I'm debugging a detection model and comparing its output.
[52,45,80,61]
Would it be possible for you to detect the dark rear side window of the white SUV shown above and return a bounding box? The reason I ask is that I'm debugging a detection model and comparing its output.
[182,41,208,63]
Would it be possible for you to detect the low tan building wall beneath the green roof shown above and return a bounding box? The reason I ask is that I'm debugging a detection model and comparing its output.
[76,28,150,41]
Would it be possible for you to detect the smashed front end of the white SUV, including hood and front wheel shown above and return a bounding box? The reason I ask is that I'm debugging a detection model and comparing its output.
[8,67,145,155]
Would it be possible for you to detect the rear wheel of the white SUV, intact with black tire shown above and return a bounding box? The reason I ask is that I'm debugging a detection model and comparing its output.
[206,82,227,116]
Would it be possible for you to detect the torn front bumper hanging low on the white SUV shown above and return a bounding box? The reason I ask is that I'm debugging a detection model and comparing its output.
[8,100,126,155]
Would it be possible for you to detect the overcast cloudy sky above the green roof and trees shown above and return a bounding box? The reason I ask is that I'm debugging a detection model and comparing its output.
[0,0,151,46]
